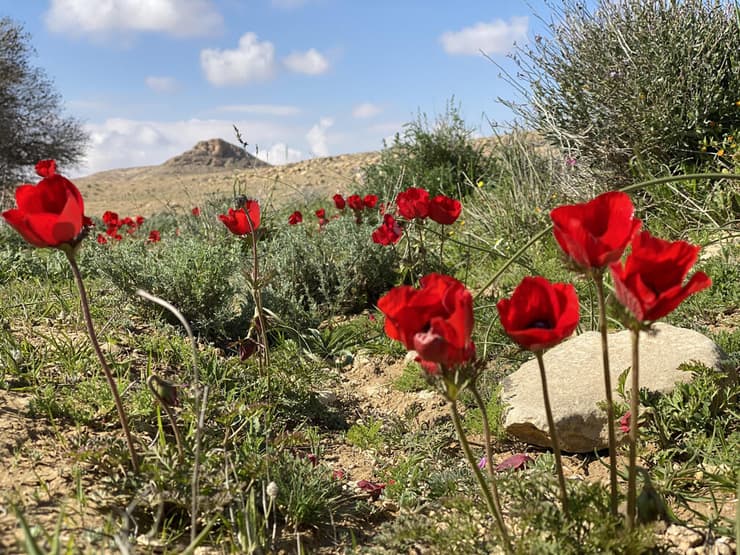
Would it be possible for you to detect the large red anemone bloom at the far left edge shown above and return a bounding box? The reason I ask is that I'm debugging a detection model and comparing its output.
[2,160,85,247]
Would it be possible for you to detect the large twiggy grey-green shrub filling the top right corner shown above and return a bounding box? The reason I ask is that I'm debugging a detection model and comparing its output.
[507,0,740,180]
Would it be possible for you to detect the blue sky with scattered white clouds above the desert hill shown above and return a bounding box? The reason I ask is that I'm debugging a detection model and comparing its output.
[0,0,546,176]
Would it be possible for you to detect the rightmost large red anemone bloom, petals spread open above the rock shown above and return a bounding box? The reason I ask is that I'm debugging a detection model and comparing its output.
[609,231,712,322]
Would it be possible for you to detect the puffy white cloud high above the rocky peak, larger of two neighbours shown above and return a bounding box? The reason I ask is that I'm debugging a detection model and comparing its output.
[200,33,275,87]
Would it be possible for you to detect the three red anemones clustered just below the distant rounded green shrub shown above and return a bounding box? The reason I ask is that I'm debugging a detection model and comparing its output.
[372,187,462,246]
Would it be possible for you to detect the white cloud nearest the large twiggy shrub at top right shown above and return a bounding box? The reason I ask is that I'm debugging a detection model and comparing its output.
[439,17,529,55]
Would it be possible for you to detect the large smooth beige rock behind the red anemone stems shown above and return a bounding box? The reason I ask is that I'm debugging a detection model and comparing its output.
[503,323,726,453]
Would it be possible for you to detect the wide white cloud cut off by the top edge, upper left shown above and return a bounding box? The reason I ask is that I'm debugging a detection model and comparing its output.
[44,0,223,37]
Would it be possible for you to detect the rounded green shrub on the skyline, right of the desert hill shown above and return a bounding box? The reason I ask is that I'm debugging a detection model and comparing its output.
[364,102,496,199]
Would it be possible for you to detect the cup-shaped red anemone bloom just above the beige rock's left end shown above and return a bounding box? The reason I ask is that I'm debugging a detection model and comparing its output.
[496,277,579,352]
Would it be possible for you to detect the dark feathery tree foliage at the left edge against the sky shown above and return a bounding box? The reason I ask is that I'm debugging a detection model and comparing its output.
[0,17,87,193]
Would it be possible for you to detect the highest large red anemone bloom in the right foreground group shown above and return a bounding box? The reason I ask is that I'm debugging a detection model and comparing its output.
[550,191,642,270]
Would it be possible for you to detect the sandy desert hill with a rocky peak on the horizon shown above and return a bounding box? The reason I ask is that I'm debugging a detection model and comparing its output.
[74,139,380,217]
